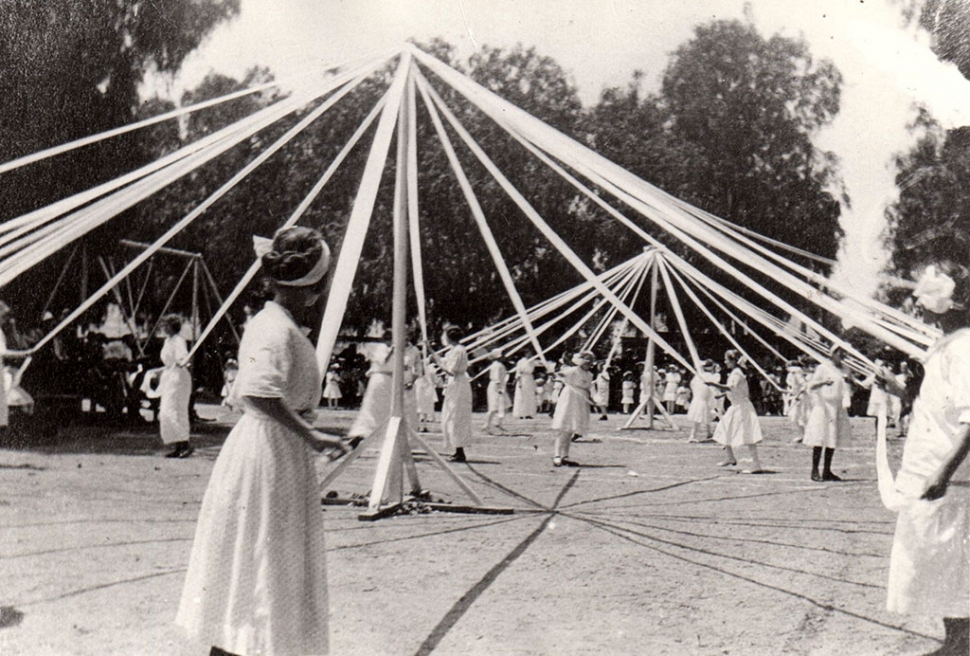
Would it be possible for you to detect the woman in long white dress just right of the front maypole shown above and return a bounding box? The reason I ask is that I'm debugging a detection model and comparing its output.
[431,326,472,462]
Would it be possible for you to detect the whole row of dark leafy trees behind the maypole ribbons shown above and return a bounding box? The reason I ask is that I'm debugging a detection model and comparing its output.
[0,0,952,358]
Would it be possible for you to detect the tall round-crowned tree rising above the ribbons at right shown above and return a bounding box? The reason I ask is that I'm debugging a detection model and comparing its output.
[662,21,842,257]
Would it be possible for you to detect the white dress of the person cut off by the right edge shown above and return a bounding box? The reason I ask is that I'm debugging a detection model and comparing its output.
[887,329,970,617]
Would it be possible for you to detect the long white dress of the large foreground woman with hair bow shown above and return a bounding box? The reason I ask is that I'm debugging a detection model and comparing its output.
[176,302,329,656]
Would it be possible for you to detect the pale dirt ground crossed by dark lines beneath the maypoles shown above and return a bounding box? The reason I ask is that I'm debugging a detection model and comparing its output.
[0,407,942,656]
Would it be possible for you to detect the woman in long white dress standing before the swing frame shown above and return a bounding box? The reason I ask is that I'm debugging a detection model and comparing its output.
[158,314,194,458]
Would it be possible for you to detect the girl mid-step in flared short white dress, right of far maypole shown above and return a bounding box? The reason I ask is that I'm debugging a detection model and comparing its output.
[711,349,764,474]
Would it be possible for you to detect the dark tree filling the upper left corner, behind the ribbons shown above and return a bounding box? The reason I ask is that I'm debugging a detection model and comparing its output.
[0,0,239,316]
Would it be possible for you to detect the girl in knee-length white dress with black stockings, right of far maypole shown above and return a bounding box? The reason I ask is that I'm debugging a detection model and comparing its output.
[802,347,851,481]
